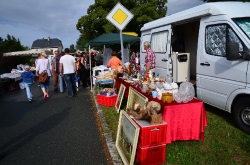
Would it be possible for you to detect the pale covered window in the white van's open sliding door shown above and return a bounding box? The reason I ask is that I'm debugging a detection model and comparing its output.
[151,31,168,53]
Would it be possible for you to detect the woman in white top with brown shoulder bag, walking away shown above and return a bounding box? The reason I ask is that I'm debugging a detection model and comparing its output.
[36,52,52,98]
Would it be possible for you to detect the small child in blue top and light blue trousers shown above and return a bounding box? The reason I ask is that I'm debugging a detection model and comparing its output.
[21,65,36,102]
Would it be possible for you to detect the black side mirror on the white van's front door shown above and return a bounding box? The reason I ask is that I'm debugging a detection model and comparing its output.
[226,43,239,61]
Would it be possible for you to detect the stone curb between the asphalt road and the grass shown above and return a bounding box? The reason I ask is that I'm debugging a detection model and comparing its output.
[92,90,123,165]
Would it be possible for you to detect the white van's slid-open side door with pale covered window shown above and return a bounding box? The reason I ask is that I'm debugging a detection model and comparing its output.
[150,25,172,77]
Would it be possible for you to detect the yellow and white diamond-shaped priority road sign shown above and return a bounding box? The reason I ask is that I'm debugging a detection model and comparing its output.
[106,2,134,30]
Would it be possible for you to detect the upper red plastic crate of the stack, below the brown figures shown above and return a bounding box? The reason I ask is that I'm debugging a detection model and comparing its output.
[134,120,167,148]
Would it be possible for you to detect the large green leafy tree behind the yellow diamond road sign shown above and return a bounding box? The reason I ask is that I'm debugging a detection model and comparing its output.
[76,0,167,41]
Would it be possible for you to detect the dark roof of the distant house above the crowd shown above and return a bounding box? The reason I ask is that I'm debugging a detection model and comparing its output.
[31,38,63,49]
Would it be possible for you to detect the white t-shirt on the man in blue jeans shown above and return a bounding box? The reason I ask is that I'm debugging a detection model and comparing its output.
[60,54,75,74]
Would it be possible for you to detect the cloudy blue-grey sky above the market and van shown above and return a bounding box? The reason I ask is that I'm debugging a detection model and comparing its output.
[0,0,202,48]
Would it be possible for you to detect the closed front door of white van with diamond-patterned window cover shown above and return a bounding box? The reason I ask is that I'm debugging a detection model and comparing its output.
[197,18,248,110]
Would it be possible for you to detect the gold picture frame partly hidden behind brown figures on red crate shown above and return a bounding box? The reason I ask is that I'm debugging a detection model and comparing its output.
[126,87,148,109]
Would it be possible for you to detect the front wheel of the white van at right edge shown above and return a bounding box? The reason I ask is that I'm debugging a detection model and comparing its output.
[233,97,250,135]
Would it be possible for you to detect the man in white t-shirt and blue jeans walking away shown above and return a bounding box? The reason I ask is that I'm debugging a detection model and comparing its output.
[59,48,76,98]
